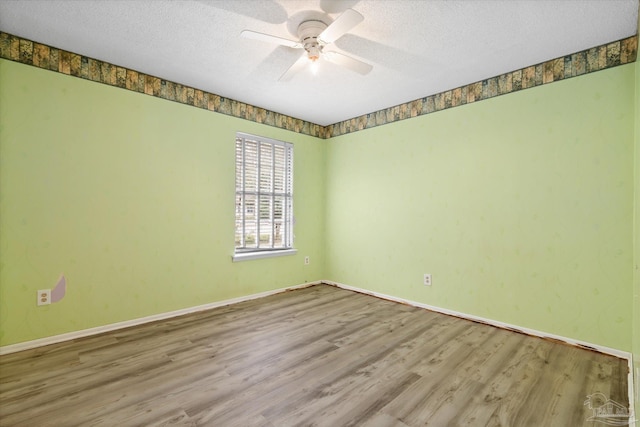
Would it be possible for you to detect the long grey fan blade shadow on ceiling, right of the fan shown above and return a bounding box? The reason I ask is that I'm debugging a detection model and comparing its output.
[334,34,438,79]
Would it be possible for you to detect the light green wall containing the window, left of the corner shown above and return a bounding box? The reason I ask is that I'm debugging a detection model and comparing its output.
[0,60,325,346]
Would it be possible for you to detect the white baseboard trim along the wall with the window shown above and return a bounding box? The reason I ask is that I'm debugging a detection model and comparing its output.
[0,281,322,355]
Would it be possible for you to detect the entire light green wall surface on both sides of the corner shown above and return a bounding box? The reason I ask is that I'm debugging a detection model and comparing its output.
[0,55,640,354]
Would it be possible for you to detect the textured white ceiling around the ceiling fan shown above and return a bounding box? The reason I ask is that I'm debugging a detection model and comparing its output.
[0,0,638,125]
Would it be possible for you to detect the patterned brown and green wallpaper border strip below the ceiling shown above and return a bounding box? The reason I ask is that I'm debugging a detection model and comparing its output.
[0,31,638,139]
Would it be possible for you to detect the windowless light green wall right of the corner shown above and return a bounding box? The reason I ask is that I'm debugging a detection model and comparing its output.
[326,64,635,351]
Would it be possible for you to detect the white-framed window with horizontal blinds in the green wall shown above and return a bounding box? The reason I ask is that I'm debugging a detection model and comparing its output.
[234,133,295,261]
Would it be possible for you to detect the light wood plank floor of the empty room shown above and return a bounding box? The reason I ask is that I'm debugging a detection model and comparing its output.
[0,285,628,427]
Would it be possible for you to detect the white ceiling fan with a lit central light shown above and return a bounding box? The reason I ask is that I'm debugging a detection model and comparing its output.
[240,9,373,81]
